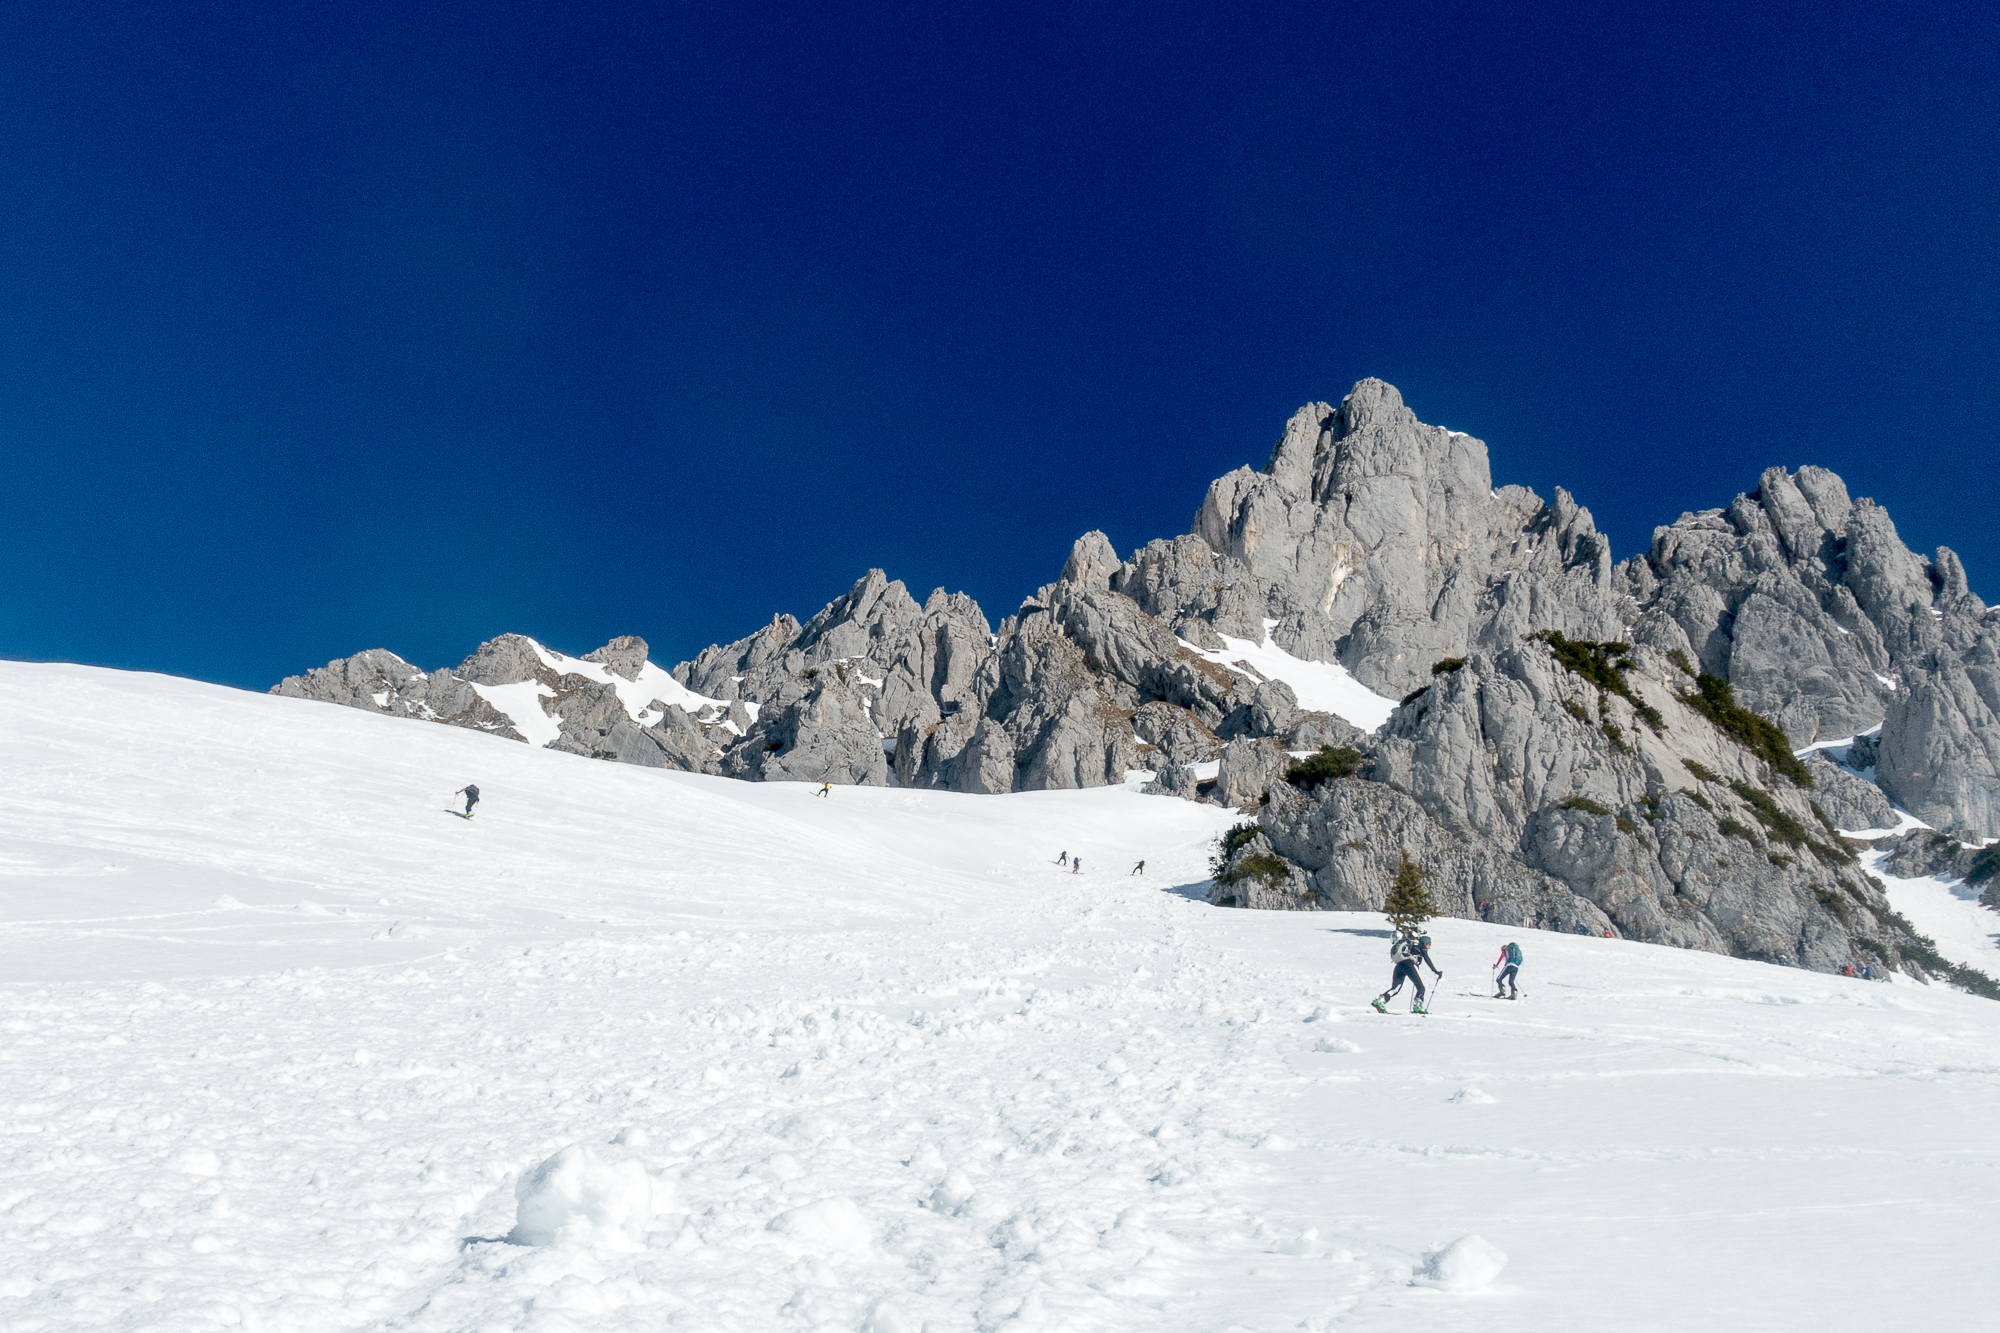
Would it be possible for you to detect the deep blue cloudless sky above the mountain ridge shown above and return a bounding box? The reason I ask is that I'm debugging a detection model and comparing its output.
[0,0,2000,689]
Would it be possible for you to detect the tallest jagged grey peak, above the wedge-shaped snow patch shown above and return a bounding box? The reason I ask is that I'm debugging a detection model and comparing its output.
[1168,370,1618,697]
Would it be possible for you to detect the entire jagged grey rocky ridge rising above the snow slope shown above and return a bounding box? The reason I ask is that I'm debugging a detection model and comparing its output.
[276,380,2000,967]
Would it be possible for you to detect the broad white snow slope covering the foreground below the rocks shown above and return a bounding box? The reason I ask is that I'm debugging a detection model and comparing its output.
[0,662,2000,1333]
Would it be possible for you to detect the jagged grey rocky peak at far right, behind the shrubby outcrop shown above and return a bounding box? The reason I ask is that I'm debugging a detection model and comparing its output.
[1616,456,2000,837]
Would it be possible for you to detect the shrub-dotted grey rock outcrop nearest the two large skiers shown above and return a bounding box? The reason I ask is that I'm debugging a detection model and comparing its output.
[1262,640,1904,971]
